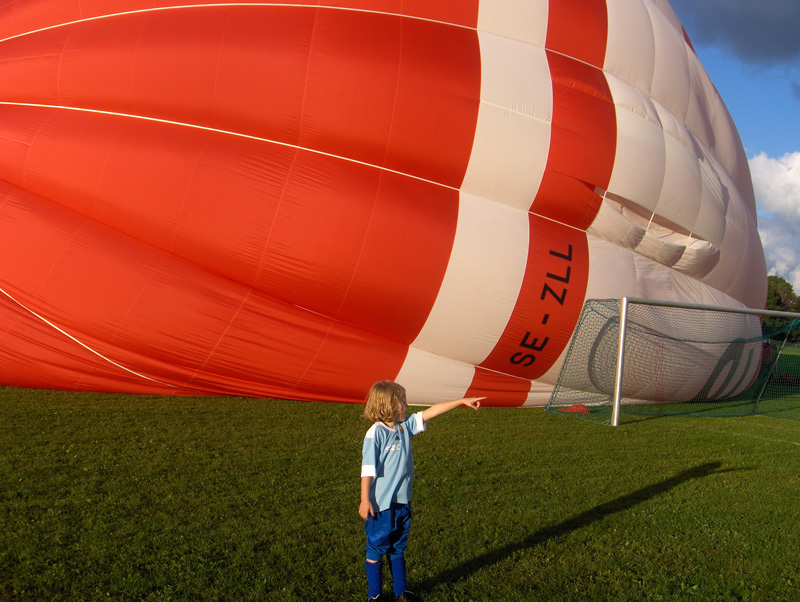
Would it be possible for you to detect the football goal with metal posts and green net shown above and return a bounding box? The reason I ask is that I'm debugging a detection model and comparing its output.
[546,297,800,426]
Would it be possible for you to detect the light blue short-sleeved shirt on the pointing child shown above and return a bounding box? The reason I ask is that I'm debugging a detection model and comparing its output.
[361,412,425,512]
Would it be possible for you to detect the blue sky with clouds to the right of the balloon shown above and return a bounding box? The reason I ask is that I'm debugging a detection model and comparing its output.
[671,0,800,294]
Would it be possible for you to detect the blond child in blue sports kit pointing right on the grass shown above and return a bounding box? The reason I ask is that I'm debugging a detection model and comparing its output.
[358,381,485,602]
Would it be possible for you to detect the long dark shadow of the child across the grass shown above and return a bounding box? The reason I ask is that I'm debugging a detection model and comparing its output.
[416,462,741,592]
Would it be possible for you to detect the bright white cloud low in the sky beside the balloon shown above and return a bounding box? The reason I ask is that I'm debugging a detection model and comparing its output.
[750,152,800,293]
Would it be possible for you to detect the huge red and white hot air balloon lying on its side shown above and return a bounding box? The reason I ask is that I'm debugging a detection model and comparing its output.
[0,0,766,405]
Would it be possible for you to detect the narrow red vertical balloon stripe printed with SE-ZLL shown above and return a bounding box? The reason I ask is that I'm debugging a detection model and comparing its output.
[468,0,616,405]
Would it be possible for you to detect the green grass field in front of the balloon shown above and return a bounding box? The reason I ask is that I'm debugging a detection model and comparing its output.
[0,388,800,602]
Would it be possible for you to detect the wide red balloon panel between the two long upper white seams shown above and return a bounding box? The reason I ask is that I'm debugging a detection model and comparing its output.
[3,6,480,186]
